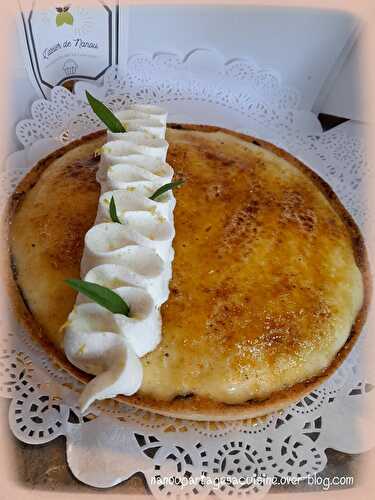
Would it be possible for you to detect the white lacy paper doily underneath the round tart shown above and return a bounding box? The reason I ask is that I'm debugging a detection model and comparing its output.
[0,51,374,497]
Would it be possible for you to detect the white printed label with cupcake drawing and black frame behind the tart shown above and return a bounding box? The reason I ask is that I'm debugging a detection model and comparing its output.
[19,0,127,97]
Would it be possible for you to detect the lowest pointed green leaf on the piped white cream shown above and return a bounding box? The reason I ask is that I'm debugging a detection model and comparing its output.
[65,279,130,316]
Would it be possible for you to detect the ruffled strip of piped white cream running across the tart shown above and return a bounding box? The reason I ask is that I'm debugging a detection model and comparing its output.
[64,105,176,411]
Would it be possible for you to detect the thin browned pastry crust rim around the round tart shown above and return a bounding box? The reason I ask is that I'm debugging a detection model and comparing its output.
[7,124,371,421]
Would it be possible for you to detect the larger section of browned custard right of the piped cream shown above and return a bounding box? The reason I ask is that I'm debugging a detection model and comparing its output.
[141,131,362,402]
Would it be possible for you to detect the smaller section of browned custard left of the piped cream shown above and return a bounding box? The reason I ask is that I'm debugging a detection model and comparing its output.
[11,139,104,346]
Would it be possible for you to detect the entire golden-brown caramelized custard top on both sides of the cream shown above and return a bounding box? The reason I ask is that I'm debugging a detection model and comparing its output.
[12,129,363,403]
